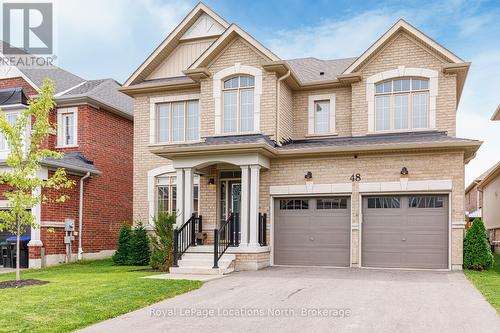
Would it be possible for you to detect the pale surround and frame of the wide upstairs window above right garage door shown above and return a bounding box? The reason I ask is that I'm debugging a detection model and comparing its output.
[366,66,439,134]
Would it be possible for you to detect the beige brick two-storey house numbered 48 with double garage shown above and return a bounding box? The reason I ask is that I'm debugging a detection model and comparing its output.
[120,3,481,273]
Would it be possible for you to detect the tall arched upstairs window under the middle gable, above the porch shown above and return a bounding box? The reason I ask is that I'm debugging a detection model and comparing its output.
[222,75,255,133]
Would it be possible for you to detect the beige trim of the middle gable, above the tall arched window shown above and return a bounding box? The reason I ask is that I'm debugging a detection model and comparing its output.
[187,23,280,72]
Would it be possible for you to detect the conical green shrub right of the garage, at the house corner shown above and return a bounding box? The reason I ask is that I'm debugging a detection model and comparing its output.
[464,218,493,271]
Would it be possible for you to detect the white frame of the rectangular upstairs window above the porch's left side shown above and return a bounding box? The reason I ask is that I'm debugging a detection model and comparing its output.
[149,94,201,145]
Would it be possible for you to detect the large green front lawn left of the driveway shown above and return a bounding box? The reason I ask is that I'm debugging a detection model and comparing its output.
[0,260,202,332]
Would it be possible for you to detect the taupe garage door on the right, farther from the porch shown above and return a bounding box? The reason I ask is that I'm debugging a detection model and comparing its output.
[361,195,449,268]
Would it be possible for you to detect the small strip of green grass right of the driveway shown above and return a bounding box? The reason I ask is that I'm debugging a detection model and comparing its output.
[464,254,500,314]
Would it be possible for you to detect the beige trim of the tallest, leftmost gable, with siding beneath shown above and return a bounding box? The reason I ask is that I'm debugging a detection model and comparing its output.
[123,2,229,87]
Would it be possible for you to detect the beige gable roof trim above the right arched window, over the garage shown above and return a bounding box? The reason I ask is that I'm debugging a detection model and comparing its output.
[343,19,465,74]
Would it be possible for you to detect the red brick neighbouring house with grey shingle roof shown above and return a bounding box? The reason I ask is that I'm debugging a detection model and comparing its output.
[0,44,133,267]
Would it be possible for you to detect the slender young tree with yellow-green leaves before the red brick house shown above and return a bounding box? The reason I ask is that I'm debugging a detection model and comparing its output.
[0,79,74,281]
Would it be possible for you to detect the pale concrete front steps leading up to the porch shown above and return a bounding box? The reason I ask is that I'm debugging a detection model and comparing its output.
[170,245,236,275]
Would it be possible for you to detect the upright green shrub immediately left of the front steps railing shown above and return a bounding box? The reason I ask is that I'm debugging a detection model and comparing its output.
[150,212,175,272]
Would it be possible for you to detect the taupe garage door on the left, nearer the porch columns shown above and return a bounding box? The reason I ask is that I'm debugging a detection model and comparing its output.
[274,197,351,266]
